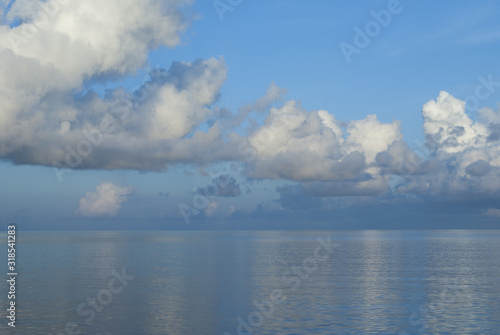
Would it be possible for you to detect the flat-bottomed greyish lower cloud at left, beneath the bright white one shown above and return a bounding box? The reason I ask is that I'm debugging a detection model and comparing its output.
[0,55,226,170]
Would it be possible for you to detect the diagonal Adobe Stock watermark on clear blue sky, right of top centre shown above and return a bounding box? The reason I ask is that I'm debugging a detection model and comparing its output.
[339,0,411,64]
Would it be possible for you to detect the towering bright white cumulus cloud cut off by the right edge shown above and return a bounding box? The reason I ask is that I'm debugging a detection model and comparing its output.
[397,91,500,199]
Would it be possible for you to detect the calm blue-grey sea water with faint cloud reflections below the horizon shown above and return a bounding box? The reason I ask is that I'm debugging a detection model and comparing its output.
[0,231,500,335]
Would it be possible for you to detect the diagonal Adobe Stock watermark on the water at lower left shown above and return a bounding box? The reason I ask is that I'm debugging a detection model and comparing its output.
[47,268,135,335]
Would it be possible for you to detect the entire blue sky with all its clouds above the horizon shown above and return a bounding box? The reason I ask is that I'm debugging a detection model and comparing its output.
[0,0,500,230]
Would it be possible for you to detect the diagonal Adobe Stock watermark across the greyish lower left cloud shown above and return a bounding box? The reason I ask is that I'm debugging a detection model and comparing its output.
[52,67,167,183]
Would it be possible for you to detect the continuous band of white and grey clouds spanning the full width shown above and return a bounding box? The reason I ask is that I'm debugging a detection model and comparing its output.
[0,0,500,205]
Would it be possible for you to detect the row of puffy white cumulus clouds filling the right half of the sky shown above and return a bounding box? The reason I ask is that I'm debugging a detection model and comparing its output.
[241,91,500,203]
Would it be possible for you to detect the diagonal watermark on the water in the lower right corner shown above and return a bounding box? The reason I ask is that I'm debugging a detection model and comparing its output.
[399,279,470,335]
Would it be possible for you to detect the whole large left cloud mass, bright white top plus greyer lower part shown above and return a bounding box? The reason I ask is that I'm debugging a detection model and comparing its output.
[0,0,237,171]
